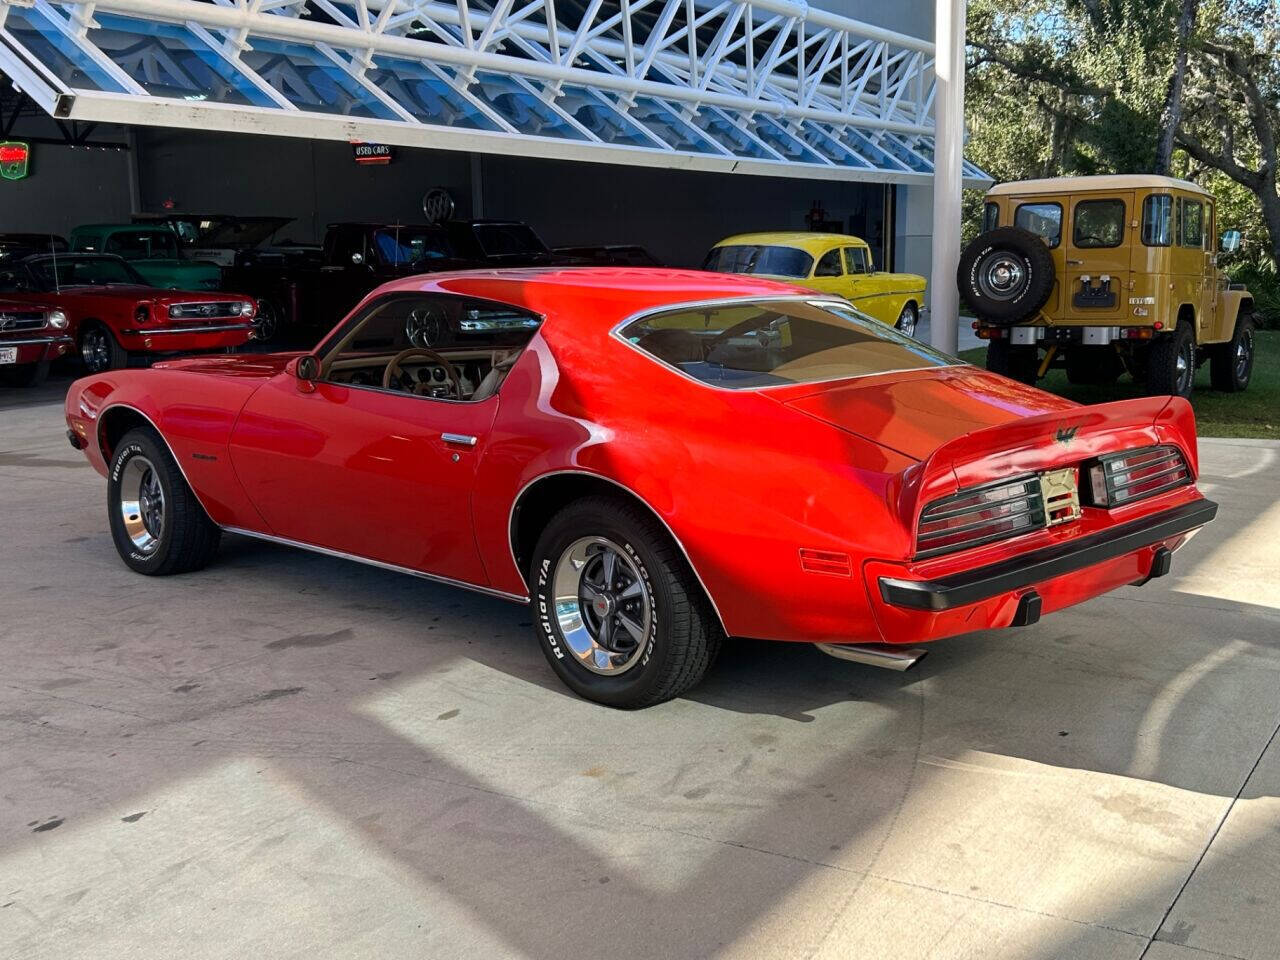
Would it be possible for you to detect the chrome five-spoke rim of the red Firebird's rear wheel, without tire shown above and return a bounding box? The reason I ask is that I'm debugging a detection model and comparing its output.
[552,536,653,676]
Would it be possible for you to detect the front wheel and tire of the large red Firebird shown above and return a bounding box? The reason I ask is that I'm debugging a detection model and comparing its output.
[106,428,221,576]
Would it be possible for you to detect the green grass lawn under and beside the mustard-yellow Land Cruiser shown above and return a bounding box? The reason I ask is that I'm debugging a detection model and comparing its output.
[960,330,1280,440]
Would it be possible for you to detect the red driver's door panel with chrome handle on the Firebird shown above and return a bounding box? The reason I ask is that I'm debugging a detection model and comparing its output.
[230,374,498,585]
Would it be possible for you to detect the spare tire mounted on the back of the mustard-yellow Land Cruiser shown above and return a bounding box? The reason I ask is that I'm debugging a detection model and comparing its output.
[956,227,1053,324]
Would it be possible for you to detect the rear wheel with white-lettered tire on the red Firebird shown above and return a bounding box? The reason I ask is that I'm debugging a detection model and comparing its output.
[530,497,722,709]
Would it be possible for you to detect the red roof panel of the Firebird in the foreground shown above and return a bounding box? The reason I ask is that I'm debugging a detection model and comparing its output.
[378,266,831,337]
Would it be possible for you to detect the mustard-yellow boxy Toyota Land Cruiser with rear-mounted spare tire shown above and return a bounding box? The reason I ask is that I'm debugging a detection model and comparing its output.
[957,174,1254,397]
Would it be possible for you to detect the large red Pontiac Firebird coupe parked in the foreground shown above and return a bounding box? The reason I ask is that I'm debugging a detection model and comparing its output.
[67,268,1216,707]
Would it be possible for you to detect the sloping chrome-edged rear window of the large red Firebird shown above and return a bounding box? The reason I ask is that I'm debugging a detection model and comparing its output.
[618,300,963,389]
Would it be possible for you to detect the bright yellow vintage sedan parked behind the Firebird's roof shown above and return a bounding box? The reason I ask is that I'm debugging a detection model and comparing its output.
[703,230,924,337]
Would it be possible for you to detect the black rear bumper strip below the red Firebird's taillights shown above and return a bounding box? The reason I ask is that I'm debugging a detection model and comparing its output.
[879,499,1217,611]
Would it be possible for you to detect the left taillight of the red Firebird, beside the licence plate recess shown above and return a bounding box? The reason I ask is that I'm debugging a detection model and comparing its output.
[915,475,1044,558]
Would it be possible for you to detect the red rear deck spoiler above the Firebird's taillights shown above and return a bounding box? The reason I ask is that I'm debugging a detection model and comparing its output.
[899,397,1199,530]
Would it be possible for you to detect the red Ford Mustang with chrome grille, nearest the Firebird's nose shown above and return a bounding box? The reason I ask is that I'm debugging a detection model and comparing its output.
[0,252,257,374]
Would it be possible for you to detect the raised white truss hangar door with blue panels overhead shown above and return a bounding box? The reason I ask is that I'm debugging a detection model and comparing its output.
[0,0,989,186]
